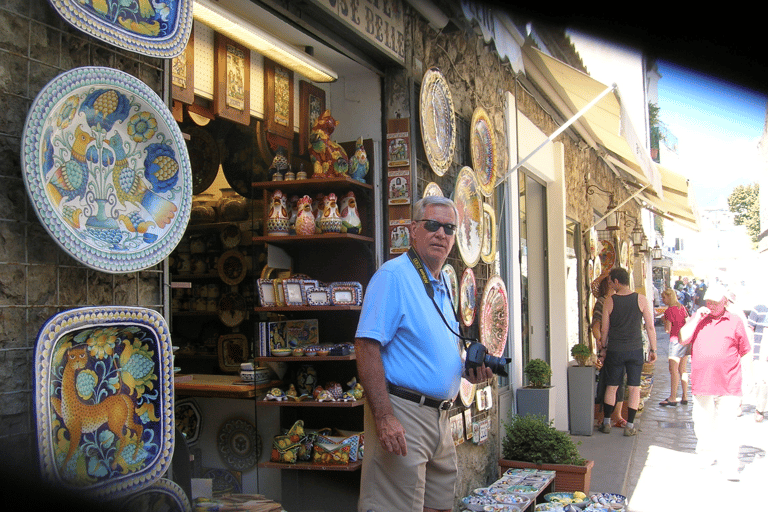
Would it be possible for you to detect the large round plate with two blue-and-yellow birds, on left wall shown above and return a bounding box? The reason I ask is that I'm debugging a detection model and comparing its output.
[21,67,192,273]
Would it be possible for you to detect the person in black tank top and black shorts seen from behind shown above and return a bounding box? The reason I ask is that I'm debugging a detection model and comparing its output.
[598,267,656,436]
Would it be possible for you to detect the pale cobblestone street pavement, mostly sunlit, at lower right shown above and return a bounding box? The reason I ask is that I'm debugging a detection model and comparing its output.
[624,326,768,512]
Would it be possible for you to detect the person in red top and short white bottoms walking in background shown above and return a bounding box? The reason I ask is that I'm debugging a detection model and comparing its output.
[659,288,691,406]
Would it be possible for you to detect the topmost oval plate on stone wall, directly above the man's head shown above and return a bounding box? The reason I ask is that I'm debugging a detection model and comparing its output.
[420,68,456,176]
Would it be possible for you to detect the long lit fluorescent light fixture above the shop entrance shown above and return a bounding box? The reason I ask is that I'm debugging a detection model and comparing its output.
[193,0,339,82]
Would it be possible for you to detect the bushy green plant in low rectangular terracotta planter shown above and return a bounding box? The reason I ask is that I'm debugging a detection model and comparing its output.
[499,414,595,494]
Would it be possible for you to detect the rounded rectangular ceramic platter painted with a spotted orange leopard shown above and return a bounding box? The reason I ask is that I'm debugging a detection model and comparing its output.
[34,306,174,498]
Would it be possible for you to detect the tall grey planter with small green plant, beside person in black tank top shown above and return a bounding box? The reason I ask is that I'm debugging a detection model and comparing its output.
[568,343,595,436]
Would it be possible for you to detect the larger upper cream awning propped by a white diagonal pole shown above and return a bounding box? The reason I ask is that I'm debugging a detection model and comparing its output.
[523,45,664,197]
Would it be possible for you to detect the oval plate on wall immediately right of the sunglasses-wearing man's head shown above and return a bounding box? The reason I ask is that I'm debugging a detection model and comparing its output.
[453,167,483,268]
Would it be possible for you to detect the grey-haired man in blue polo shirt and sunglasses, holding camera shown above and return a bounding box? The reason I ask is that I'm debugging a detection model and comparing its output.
[355,196,493,512]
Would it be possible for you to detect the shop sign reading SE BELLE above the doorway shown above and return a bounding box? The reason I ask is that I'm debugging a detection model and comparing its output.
[312,0,405,64]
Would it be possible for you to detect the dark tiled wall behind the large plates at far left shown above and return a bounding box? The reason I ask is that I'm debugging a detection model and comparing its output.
[0,0,164,471]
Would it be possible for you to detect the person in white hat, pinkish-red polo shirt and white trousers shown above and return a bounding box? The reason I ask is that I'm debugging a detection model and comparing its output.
[680,284,750,481]
